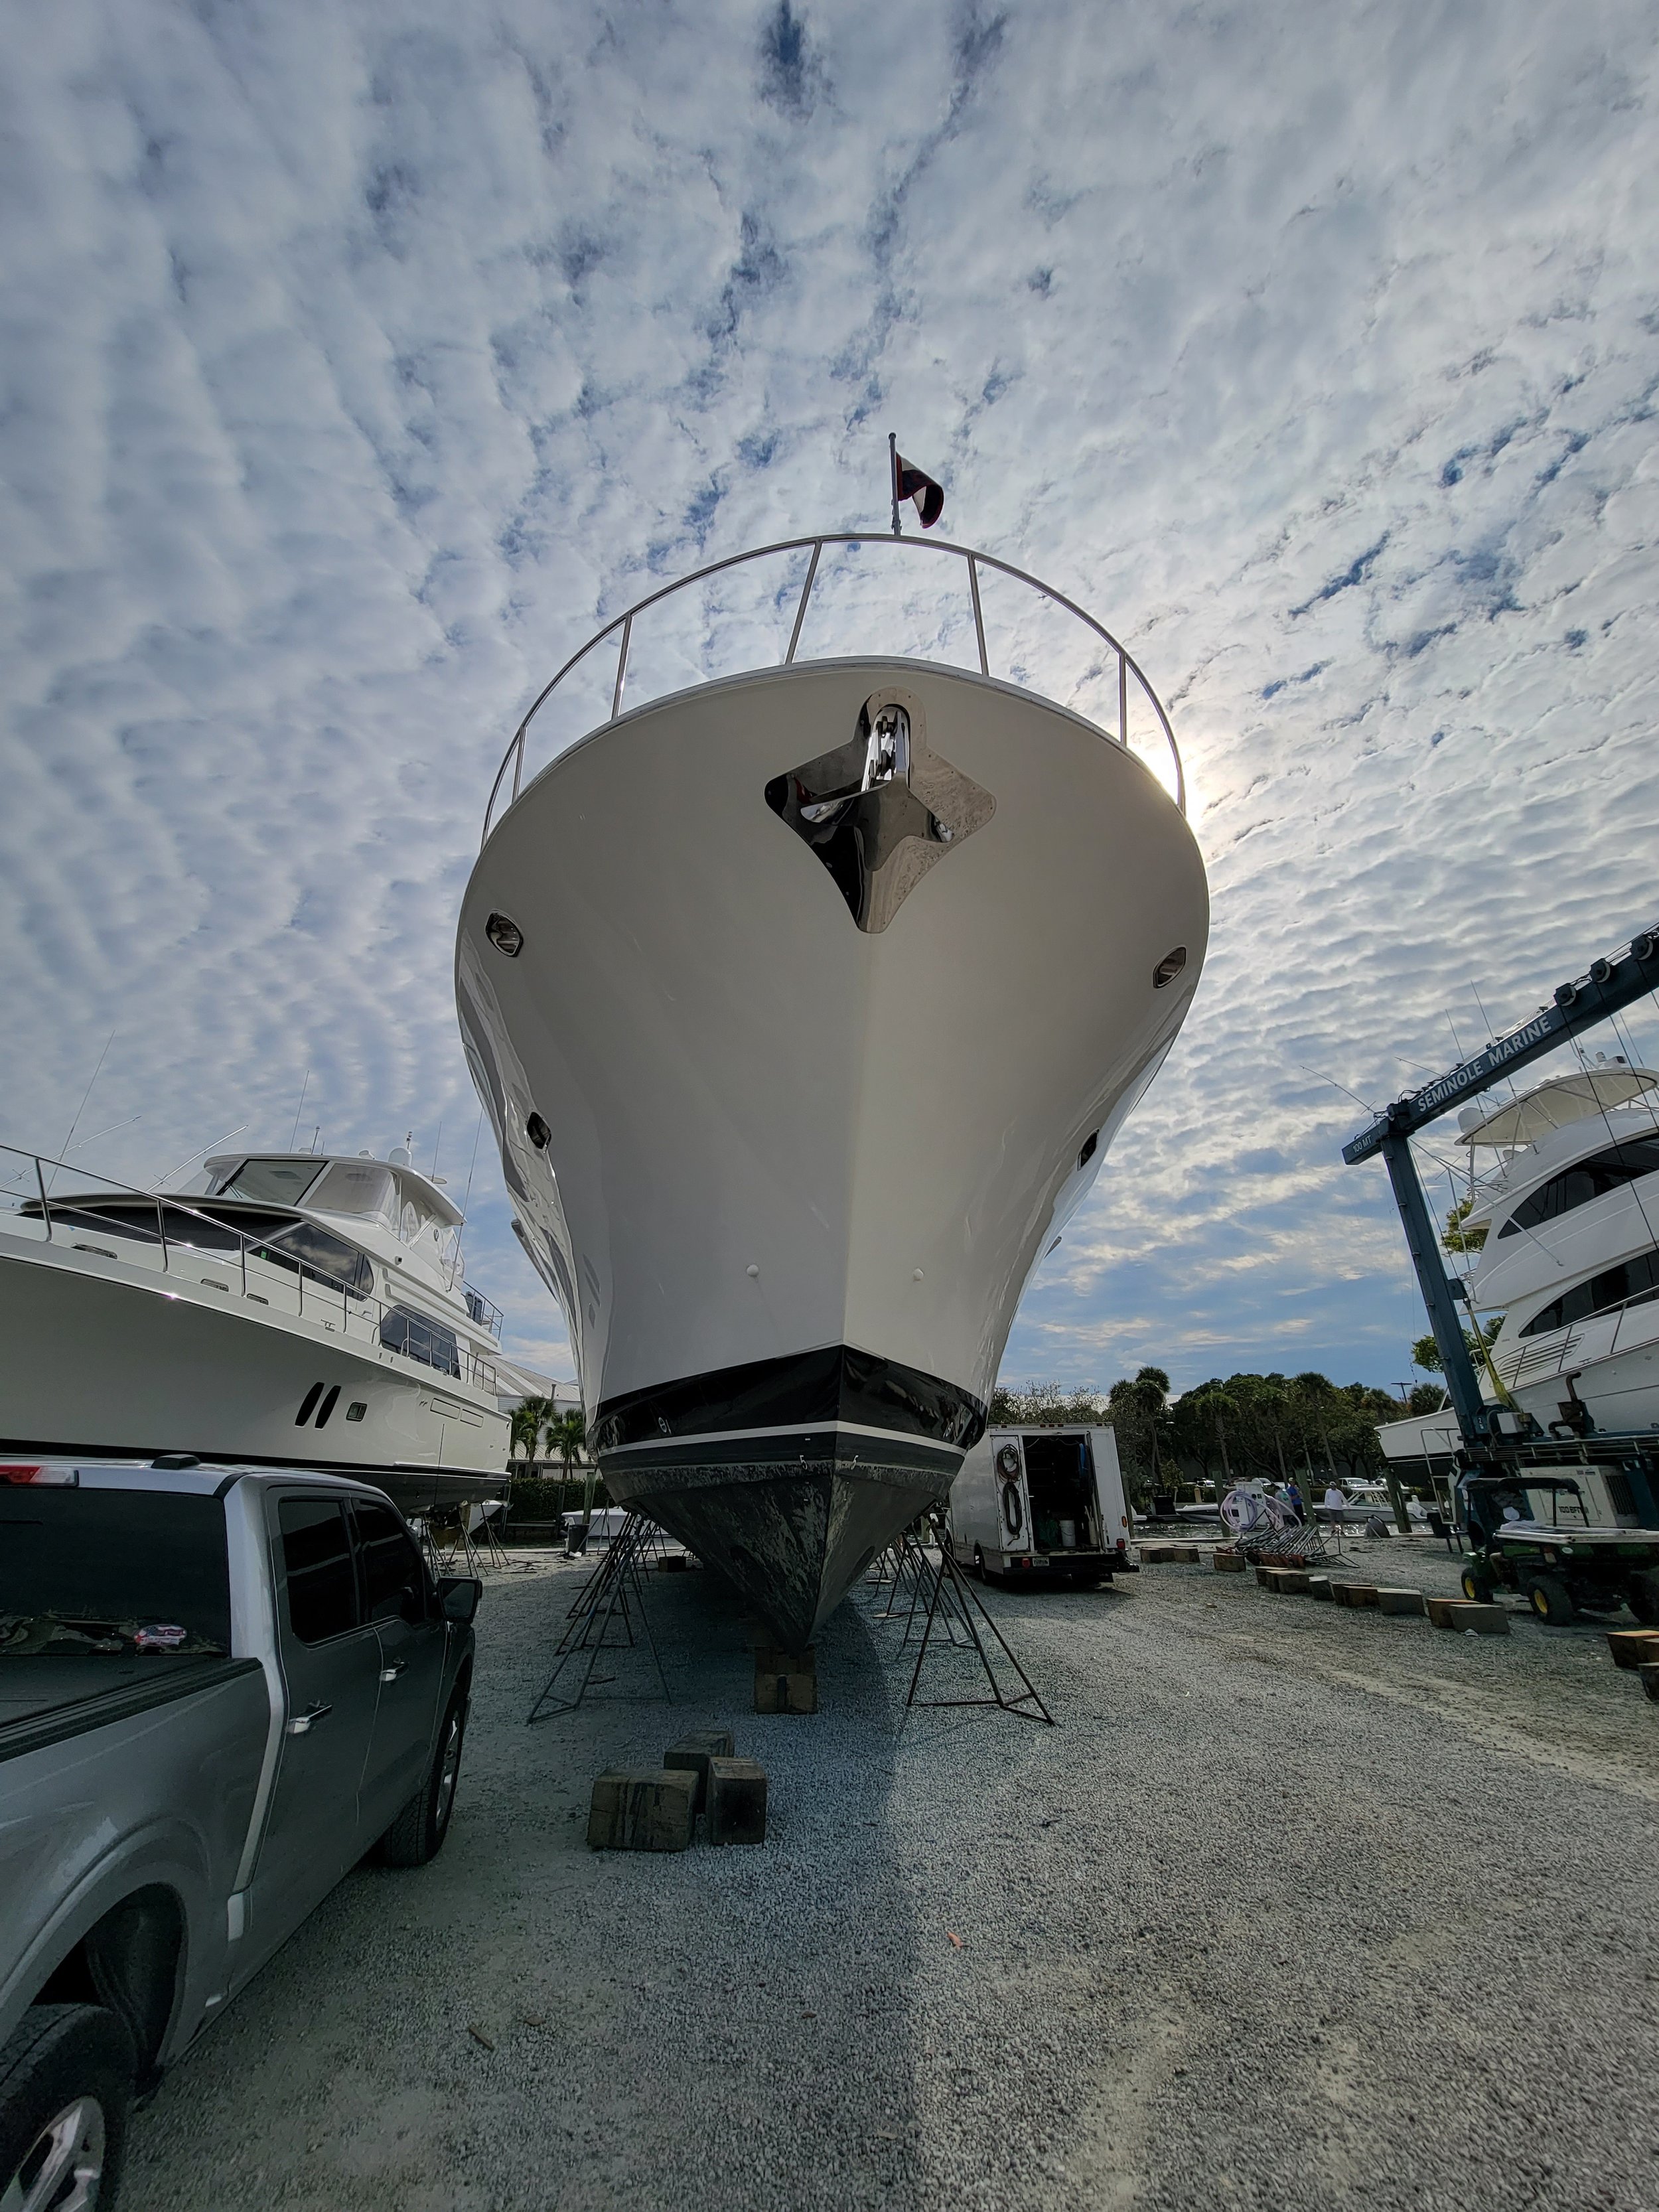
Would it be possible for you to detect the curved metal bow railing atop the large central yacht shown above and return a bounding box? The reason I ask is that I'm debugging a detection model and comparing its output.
[484,531,1186,838]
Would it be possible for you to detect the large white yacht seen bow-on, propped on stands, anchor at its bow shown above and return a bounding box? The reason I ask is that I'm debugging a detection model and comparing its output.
[456,538,1208,1650]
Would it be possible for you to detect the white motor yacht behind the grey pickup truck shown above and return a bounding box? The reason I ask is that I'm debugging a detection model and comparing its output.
[0,1148,522,1511]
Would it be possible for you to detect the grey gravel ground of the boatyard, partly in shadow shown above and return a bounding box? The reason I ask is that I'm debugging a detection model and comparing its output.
[124,1540,1659,2212]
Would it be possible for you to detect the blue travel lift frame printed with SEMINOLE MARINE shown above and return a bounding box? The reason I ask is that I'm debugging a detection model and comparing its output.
[1342,922,1659,1526]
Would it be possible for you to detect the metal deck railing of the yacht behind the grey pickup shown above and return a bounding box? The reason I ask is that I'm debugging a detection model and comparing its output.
[0,1143,500,1394]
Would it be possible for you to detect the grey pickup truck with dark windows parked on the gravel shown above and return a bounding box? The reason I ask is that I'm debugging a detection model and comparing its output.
[0,1460,480,2212]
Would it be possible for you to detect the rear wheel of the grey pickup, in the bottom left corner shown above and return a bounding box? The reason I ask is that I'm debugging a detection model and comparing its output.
[0,2004,137,2212]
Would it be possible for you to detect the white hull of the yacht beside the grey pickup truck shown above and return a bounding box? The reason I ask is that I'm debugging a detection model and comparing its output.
[0,1232,509,1511]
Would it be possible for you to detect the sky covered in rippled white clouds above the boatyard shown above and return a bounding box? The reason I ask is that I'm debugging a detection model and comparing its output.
[0,0,1659,1382]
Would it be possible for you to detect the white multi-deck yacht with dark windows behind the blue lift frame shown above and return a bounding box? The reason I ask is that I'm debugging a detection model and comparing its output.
[1460,1057,1659,1438]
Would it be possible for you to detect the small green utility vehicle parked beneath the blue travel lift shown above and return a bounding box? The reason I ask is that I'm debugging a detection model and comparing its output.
[1458,1469,1659,1628]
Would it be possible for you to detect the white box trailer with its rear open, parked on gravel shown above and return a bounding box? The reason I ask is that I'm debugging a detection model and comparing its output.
[947,1427,1135,1584]
